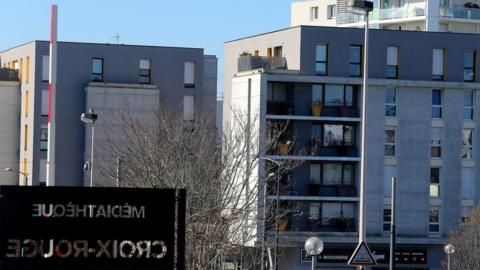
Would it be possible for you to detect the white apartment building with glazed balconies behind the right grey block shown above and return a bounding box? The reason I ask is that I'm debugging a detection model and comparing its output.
[291,0,480,34]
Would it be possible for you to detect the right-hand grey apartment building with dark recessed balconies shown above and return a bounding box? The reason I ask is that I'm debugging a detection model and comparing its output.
[224,26,480,270]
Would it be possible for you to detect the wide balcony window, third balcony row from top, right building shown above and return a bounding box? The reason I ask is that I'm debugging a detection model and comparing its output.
[310,163,355,185]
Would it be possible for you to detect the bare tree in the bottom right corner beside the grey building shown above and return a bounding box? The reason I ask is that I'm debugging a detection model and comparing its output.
[448,205,480,270]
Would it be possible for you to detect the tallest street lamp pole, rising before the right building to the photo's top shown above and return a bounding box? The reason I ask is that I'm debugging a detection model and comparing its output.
[349,0,373,269]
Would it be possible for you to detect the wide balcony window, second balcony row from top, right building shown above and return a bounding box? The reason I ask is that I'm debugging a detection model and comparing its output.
[323,124,355,146]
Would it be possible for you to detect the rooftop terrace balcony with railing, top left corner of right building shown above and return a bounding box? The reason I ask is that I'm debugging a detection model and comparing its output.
[238,55,287,72]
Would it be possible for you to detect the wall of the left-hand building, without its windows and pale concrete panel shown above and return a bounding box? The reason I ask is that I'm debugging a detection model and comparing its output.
[0,41,216,186]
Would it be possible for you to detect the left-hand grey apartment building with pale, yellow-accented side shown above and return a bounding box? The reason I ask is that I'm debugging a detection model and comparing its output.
[0,41,217,186]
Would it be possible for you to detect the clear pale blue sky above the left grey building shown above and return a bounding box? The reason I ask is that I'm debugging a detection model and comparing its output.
[0,0,291,98]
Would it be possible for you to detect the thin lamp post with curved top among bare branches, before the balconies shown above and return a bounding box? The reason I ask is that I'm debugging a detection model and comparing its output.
[259,157,281,270]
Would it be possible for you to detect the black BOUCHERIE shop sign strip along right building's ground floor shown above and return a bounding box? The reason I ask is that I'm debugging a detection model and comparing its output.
[300,247,427,265]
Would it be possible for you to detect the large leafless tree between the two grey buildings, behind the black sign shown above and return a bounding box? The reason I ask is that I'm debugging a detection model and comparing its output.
[99,110,299,269]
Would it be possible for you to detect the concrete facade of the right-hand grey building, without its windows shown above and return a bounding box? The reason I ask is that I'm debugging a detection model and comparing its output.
[224,26,480,270]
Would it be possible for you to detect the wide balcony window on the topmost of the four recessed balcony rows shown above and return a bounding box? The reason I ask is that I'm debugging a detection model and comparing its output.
[312,84,356,106]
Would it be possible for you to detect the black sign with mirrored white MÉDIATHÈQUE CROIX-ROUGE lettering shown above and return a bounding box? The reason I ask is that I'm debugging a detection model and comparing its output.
[0,186,185,270]
